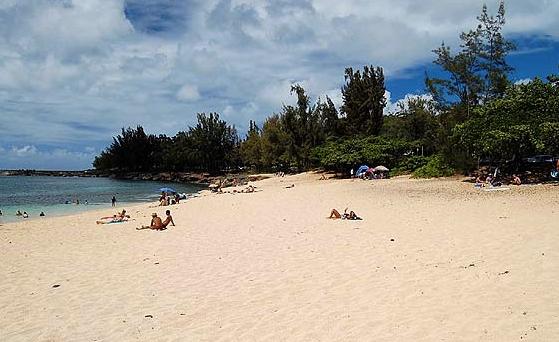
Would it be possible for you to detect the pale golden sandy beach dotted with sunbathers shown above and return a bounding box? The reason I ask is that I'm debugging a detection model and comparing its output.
[0,173,559,342]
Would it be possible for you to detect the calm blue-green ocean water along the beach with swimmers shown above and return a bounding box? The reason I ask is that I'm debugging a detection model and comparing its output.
[0,176,204,223]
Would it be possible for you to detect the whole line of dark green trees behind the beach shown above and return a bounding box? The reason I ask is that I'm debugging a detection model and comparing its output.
[93,2,559,176]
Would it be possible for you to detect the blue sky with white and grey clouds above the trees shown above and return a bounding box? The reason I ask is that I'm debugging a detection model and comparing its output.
[0,0,559,170]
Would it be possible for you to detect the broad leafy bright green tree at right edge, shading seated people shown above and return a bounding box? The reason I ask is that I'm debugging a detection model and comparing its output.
[453,79,559,166]
